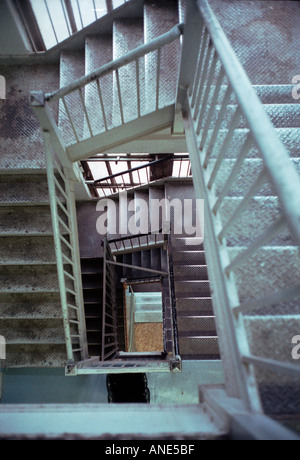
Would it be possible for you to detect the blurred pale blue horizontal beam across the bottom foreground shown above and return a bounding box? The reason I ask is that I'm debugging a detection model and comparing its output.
[0,404,224,438]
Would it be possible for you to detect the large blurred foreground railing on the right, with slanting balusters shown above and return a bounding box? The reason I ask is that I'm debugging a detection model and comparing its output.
[178,0,300,411]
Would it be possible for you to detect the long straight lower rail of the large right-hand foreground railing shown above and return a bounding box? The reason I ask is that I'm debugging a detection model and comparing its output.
[184,110,262,412]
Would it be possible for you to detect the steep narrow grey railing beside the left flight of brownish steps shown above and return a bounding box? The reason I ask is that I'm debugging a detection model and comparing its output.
[43,133,88,365]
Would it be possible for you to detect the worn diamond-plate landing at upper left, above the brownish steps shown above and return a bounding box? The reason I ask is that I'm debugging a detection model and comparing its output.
[0,61,58,174]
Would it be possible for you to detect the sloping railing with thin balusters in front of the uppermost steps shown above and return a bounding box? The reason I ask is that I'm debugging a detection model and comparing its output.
[41,25,183,155]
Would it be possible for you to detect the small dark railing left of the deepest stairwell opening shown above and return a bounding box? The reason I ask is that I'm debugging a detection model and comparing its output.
[100,238,119,361]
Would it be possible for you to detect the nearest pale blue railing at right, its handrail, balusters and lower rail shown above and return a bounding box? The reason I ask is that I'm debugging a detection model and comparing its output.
[182,0,300,412]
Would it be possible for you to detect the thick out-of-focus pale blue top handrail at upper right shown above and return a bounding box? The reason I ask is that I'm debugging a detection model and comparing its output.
[197,0,300,245]
